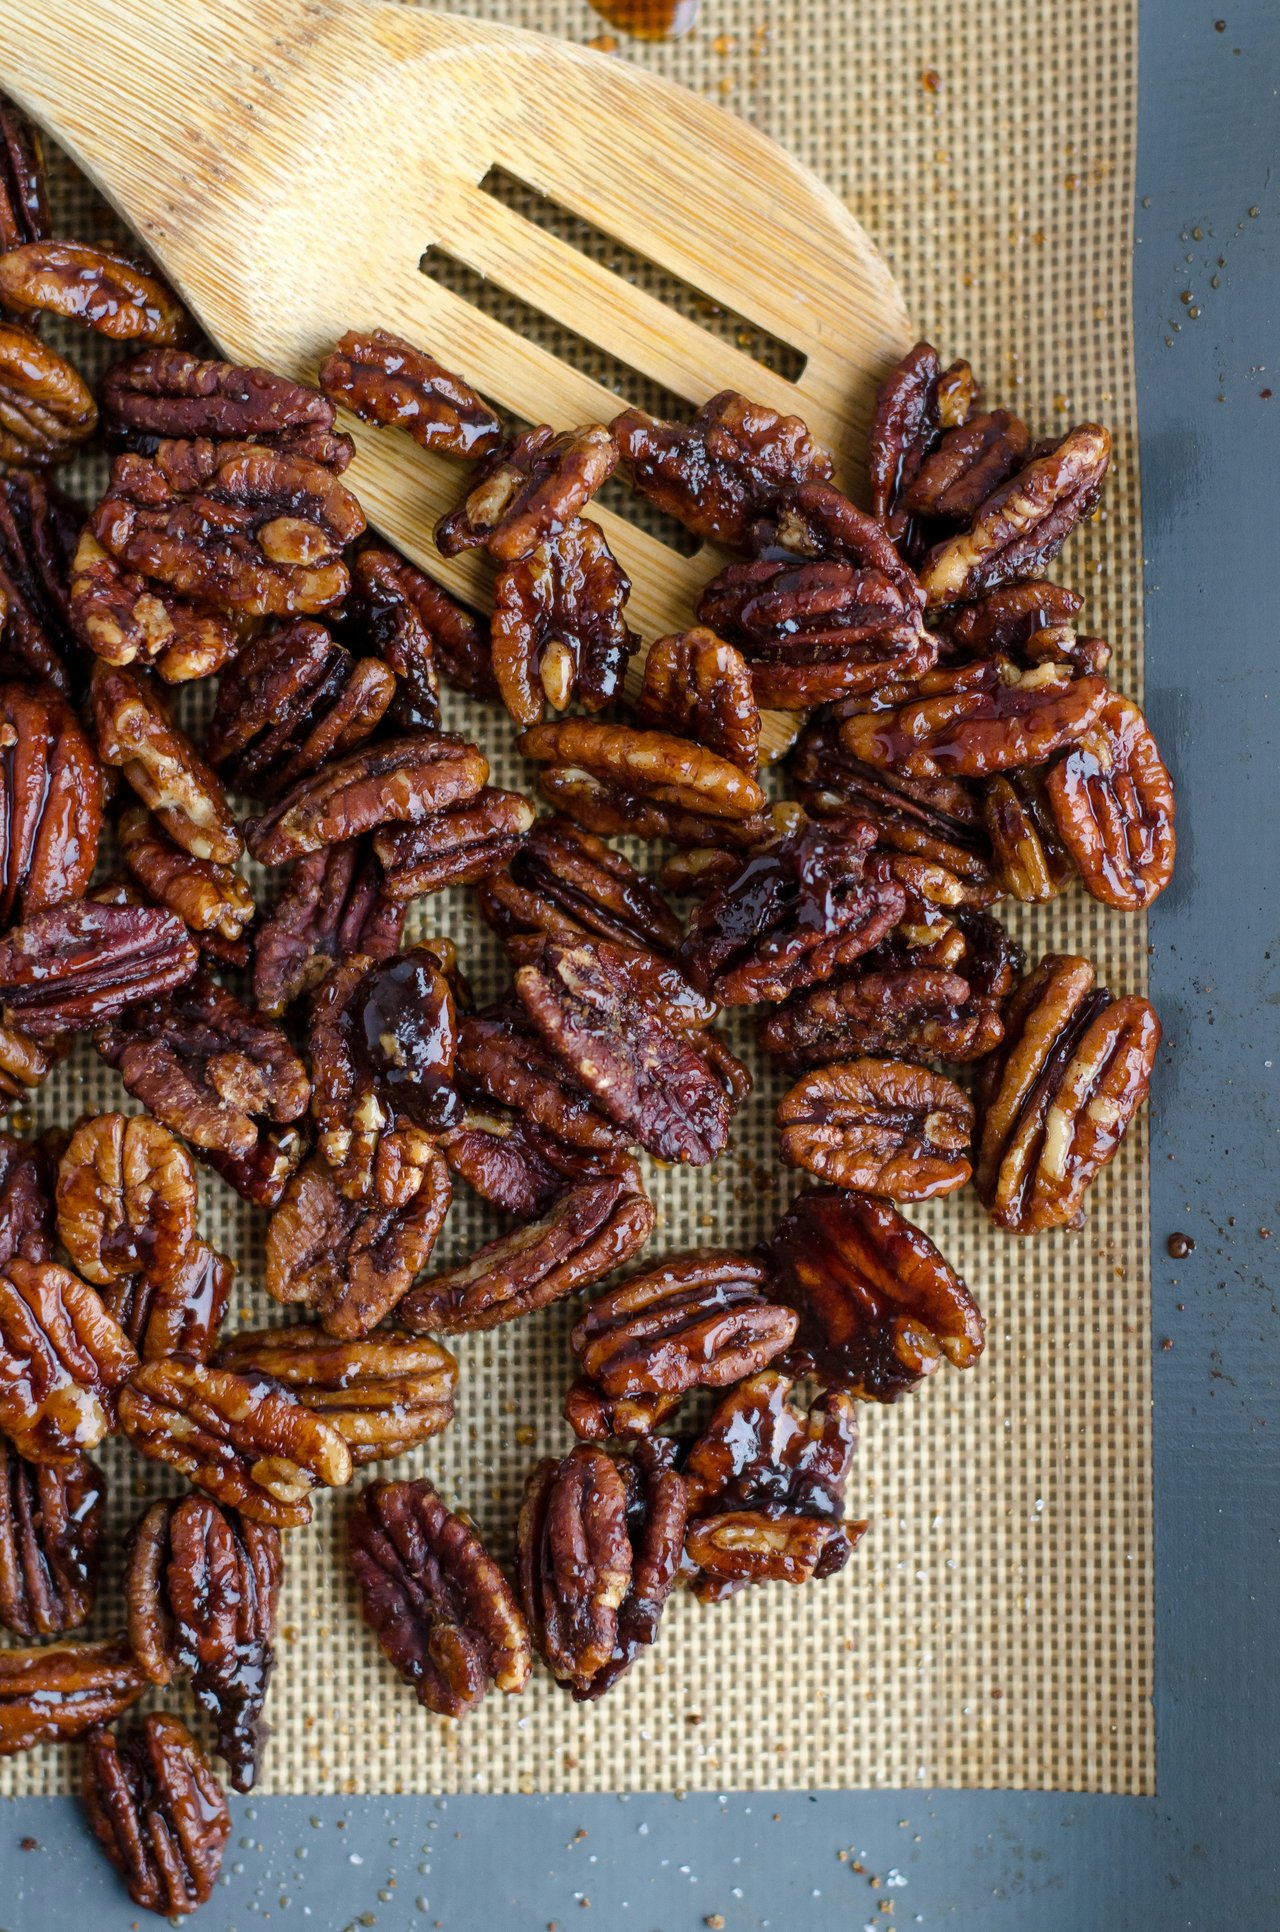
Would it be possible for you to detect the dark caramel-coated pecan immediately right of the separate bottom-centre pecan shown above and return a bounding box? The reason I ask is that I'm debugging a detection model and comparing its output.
[515,1437,685,1700]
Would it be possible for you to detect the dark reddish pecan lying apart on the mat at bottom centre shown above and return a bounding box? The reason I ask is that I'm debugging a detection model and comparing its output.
[348,1476,533,1718]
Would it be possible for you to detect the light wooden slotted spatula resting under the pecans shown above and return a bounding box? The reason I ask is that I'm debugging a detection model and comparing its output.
[0,0,911,750]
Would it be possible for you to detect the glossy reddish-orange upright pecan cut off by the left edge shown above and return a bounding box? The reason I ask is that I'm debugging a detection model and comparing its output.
[0,684,106,929]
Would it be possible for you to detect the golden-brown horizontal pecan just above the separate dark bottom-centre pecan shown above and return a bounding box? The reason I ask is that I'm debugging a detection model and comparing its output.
[218,1325,458,1464]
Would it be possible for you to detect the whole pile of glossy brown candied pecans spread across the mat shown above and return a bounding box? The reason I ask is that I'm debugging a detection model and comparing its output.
[0,94,1174,1913]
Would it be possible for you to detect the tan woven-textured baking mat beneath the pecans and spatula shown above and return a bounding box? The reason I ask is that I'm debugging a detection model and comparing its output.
[2,0,1155,1793]
